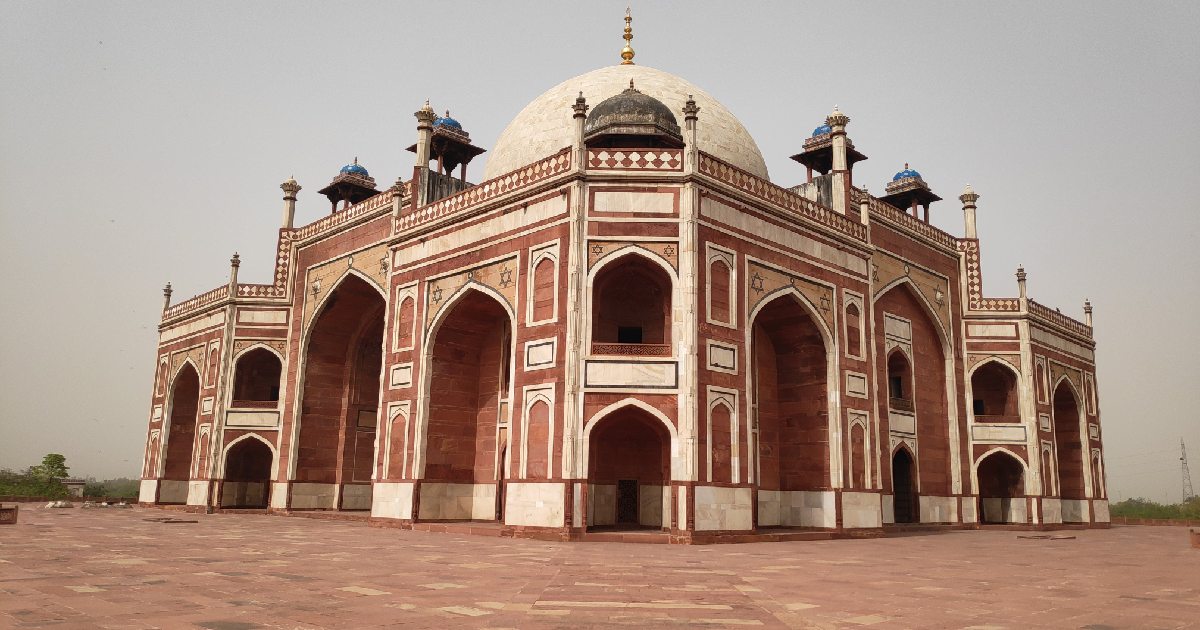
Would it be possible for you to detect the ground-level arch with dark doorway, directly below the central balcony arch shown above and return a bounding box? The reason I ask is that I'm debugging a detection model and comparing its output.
[587,406,671,529]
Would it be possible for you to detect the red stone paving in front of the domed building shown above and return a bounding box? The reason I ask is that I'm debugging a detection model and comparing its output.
[0,504,1200,630]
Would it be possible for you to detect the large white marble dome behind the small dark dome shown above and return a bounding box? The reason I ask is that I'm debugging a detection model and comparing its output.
[484,66,768,180]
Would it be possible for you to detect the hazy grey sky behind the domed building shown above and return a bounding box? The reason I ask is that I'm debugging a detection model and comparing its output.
[0,0,1200,500]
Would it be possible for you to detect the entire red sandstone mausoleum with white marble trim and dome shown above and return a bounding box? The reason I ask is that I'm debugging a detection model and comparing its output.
[140,9,1109,542]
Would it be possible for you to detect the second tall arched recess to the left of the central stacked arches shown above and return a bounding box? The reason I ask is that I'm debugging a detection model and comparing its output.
[292,274,384,510]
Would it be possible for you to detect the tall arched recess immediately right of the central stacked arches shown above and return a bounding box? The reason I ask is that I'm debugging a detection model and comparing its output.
[750,294,830,499]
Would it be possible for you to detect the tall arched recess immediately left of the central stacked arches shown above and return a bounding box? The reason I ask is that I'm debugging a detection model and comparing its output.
[419,289,512,521]
